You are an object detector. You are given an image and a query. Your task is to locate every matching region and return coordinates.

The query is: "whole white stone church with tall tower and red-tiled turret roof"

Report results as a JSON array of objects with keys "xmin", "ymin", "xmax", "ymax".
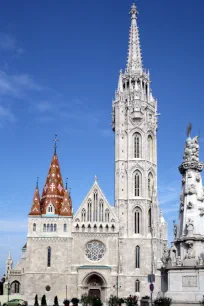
[{"xmin": 5, "ymin": 4, "xmax": 167, "ymax": 303}]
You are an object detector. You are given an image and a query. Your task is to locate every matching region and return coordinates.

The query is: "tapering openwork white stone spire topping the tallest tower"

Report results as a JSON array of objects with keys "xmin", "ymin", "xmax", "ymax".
[{"xmin": 126, "ymin": 3, "xmax": 142, "ymax": 74}]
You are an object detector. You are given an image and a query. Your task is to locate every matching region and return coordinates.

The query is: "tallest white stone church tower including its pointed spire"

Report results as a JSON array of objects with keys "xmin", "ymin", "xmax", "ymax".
[{"xmin": 112, "ymin": 4, "xmax": 167, "ymax": 294}]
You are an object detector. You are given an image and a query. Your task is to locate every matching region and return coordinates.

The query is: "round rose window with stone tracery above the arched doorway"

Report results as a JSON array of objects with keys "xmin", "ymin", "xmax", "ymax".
[{"xmin": 85, "ymin": 240, "xmax": 105, "ymax": 261}]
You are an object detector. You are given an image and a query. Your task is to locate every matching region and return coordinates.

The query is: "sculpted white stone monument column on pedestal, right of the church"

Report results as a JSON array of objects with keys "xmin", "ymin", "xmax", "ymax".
[{"xmin": 163, "ymin": 125, "xmax": 204, "ymax": 305}]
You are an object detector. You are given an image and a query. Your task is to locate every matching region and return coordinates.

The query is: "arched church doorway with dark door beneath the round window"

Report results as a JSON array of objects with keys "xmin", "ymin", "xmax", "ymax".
[{"xmin": 84, "ymin": 272, "xmax": 107, "ymax": 302}]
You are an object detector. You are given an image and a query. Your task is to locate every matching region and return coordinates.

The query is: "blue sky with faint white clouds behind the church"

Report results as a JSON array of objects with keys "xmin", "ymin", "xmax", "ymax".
[{"xmin": 0, "ymin": 0, "xmax": 204, "ymax": 275}]
